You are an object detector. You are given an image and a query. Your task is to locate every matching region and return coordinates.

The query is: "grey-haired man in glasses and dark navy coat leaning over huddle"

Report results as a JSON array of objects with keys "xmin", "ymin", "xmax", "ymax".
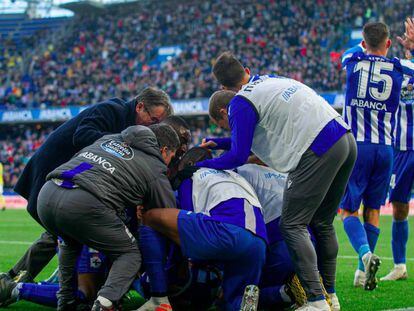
[{"xmin": 0, "ymin": 87, "xmax": 172, "ymax": 286}]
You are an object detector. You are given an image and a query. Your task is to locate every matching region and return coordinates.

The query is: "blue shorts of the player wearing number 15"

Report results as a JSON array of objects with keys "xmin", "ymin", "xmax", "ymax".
[{"xmin": 341, "ymin": 144, "xmax": 393, "ymax": 212}]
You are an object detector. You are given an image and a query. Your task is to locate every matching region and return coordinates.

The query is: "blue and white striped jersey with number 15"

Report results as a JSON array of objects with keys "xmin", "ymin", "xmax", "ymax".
[{"xmin": 342, "ymin": 46, "xmax": 414, "ymax": 145}]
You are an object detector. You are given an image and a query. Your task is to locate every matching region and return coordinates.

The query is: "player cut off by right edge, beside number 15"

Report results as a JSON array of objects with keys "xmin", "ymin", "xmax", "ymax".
[{"xmin": 381, "ymin": 73, "xmax": 414, "ymax": 281}]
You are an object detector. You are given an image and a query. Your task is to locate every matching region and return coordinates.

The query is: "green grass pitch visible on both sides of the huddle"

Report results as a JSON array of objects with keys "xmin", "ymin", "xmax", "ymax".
[{"xmin": 0, "ymin": 210, "xmax": 414, "ymax": 311}]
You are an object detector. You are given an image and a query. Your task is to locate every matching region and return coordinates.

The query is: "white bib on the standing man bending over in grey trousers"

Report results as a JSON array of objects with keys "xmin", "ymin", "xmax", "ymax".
[{"xmin": 236, "ymin": 76, "xmax": 349, "ymax": 173}]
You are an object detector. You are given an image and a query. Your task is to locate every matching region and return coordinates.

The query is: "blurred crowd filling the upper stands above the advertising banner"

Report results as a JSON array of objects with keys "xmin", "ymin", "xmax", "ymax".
[{"xmin": 0, "ymin": 0, "xmax": 414, "ymax": 109}]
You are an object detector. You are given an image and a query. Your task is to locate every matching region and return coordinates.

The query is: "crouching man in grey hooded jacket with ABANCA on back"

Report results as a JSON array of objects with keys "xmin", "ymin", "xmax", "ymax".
[{"xmin": 38, "ymin": 124, "xmax": 180, "ymax": 311}]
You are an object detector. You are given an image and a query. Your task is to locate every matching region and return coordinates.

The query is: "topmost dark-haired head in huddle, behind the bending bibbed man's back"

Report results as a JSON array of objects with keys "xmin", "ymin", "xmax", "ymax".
[{"xmin": 213, "ymin": 52, "xmax": 245, "ymax": 88}]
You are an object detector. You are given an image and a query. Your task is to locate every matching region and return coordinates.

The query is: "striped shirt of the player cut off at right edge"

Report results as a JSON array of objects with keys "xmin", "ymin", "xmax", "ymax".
[{"xmin": 394, "ymin": 77, "xmax": 414, "ymax": 151}]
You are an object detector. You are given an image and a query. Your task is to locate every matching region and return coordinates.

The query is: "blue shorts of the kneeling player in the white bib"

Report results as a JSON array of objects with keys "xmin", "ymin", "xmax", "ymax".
[{"xmin": 178, "ymin": 211, "xmax": 266, "ymax": 311}]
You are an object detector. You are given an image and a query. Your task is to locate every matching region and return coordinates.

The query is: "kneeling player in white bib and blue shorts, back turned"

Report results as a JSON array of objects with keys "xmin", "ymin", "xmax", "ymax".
[{"xmin": 139, "ymin": 148, "xmax": 267, "ymax": 311}]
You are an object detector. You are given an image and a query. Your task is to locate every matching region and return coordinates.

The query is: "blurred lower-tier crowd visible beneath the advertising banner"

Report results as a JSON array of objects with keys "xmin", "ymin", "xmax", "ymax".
[{"xmin": 0, "ymin": 116, "xmax": 227, "ymax": 189}]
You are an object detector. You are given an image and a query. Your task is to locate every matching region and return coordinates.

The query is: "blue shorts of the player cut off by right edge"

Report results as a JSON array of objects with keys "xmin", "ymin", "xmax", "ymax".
[{"xmin": 390, "ymin": 150, "xmax": 414, "ymax": 203}]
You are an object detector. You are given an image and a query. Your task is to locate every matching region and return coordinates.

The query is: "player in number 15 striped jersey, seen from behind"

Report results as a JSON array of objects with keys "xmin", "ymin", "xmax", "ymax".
[{"xmin": 341, "ymin": 22, "xmax": 414, "ymax": 290}]
